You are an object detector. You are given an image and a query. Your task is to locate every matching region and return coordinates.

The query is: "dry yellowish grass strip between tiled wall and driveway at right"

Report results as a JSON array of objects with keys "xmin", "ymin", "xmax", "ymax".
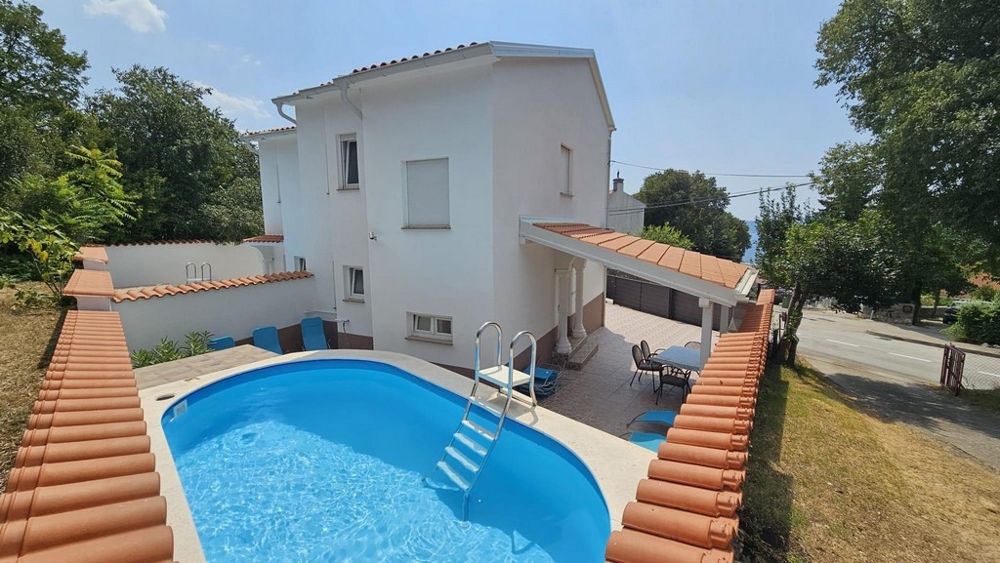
[{"xmin": 741, "ymin": 368, "xmax": 1000, "ymax": 563}]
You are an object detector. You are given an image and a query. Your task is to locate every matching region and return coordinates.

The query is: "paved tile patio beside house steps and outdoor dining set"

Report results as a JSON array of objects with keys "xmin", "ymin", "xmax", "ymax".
[{"xmin": 542, "ymin": 303, "xmax": 719, "ymax": 437}]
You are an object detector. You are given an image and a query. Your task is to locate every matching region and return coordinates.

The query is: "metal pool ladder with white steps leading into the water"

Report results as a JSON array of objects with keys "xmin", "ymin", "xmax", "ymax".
[{"xmin": 437, "ymin": 321, "xmax": 538, "ymax": 520}]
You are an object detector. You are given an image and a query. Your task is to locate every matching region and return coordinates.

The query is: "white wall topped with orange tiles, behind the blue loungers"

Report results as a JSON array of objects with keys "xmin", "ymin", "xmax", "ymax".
[{"xmin": 111, "ymin": 278, "xmax": 315, "ymax": 350}]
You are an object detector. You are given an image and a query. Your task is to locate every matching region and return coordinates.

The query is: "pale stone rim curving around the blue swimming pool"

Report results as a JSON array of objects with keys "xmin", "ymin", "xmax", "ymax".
[{"xmin": 137, "ymin": 346, "xmax": 655, "ymax": 563}]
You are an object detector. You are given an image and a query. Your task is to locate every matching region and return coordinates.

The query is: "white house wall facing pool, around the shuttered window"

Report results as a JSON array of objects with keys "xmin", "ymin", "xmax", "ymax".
[{"xmin": 362, "ymin": 61, "xmax": 496, "ymax": 367}]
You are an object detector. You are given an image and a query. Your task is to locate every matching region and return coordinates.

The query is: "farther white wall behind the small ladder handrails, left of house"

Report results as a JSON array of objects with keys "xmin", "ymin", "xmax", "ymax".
[{"xmin": 105, "ymin": 242, "xmax": 267, "ymax": 288}]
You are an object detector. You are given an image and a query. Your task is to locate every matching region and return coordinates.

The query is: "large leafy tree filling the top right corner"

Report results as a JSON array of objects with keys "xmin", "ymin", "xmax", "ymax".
[{"xmin": 816, "ymin": 0, "xmax": 1000, "ymax": 272}]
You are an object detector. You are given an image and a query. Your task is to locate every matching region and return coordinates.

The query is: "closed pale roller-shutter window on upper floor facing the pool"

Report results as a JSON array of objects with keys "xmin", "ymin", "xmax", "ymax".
[{"xmin": 403, "ymin": 158, "xmax": 451, "ymax": 229}]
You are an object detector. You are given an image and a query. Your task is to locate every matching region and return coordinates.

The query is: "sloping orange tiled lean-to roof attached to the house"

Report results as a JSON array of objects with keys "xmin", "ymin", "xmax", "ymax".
[{"xmin": 535, "ymin": 223, "xmax": 749, "ymax": 289}]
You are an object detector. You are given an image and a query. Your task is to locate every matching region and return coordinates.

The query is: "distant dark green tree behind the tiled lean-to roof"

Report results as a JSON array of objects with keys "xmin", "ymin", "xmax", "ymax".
[{"xmin": 635, "ymin": 169, "xmax": 750, "ymax": 261}]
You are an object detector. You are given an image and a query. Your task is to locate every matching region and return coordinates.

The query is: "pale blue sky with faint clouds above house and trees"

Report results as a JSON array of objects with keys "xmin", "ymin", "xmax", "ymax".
[{"xmin": 34, "ymin": 0, "xmax": 861, "ymax": 219}]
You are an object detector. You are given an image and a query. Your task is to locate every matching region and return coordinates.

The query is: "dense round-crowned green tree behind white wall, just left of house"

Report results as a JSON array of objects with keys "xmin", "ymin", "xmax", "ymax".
[{"xmin": 87, "ymin": 65, "xmax": 261, "ymax": 241}]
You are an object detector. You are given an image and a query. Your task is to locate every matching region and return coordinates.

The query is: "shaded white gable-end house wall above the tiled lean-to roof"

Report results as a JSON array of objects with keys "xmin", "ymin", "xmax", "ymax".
[{"xmin": 492, "ymin": 59, "xmax": 609, "ymax": 348}]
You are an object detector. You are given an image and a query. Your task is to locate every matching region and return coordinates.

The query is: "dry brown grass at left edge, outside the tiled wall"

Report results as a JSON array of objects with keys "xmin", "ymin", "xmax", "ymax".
[{"xmin": 0, "ymin": 284, "xmax": 64, "ymax": 491}]
